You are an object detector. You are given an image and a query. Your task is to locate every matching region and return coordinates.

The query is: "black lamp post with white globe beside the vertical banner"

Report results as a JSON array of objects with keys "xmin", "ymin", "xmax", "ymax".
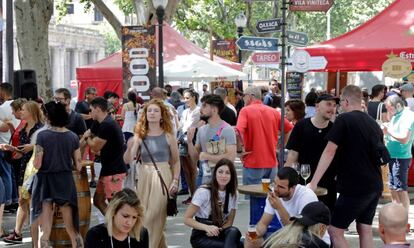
[{"xmin": 152, "ymin": 0, "xmax": 168, "ymax": 88}]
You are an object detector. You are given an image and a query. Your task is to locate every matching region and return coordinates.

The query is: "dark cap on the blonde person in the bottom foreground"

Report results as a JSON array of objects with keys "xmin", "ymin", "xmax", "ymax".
[{"xmin": 290, "ymin": 201, "xmax": 331, "ymax": 226}]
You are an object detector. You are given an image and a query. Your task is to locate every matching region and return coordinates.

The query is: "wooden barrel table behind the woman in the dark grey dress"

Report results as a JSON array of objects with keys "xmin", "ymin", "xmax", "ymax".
[{"xmin": 50, "ymin": 160, "xmax": 93, "ymax": 247}]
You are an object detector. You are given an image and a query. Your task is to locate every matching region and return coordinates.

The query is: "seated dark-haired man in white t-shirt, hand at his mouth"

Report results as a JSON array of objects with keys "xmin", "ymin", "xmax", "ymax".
[{"xmin": 245, "ymin": 167, "xmax": 330, "ymax": 247}]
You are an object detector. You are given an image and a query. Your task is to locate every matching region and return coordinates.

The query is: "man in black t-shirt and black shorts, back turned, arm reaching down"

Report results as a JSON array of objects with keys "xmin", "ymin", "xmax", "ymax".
[{"xmin": 309, "ymin": 85, "xmax": 383, "ymax": 247}]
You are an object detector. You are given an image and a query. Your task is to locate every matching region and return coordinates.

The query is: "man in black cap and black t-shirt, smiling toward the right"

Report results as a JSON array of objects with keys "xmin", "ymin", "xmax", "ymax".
[{"xmin": 286, "ymin": 94, "xmax": 339, "ymax": 212}]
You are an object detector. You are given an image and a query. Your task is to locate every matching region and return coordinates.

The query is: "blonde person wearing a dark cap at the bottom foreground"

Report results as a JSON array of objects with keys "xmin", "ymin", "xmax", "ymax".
[{"xmin": 263, "ymin": 202, "xmax": 330, "ymax": 248}]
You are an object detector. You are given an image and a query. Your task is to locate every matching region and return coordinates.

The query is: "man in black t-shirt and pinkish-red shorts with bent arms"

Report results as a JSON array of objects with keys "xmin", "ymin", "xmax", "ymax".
[{"xmin": 81, "ymin": 97, "xmax": 126, "ymax": 215}]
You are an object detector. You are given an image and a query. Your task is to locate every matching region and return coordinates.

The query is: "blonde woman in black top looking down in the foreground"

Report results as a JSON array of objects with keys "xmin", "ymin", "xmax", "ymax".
[{"xmin": 85, "ymin": 188, "xmax": 149, "ymax": 248}]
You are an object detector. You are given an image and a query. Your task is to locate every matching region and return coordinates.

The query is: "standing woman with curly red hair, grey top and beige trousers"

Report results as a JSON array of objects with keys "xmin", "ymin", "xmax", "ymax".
[{"xmin": 124, "ymin": 99, "xmax": 180, "ymax": 248}]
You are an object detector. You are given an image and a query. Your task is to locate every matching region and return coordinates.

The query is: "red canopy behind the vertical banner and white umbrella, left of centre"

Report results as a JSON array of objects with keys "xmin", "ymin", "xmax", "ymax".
[{"xmin": 76, "ymin": 25, "xmax": 242, "ymax": 98}]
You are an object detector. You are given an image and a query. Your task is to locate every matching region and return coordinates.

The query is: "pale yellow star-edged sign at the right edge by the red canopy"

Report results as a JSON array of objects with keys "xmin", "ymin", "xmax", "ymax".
[{"xmin": 382, "ymin": 53, "xmax": 413, "ymax": 78}]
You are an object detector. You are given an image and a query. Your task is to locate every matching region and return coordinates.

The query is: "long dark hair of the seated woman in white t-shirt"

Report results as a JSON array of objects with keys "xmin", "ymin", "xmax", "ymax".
[{"xmin": 208, "ymin": 158, "xmax": 238, "ymax": 227}]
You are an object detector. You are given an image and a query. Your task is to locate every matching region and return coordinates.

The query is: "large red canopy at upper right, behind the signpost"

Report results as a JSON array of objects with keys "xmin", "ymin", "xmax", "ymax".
[{"xmin": 304, "ymin": 0, "xmax": 414, "ymax": 71}]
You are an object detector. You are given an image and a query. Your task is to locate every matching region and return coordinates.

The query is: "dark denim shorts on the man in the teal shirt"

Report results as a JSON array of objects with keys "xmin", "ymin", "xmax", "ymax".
[{"xmin": 389, "ymin": 158, "xmax": 411, "ymax": 191}]
